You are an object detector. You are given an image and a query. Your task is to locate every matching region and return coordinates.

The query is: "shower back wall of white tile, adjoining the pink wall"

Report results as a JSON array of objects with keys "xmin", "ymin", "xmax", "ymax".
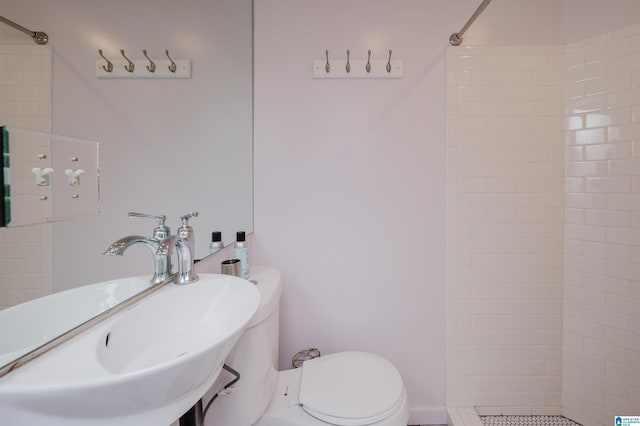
[{"xmin": 447, "ymin": 46, "xmax": 564, "ymax": 414}]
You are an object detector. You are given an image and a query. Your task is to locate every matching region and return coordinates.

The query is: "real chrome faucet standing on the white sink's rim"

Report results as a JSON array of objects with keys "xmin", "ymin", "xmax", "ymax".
[{"xmin": 156, "ymin": 212, "xmax": 198, "ymax": 284}]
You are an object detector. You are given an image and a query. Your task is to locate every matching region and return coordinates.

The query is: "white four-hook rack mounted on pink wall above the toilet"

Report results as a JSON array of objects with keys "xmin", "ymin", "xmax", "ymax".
[{"xmin": 313, "ymin": 50, "xmax": 404, "ymax": 78}]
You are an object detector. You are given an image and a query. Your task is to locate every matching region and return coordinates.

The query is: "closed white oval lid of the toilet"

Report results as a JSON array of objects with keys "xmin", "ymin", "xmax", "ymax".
[{"xmin": 299, "ymin": 352, "xmax": 404, "ymax": 426}]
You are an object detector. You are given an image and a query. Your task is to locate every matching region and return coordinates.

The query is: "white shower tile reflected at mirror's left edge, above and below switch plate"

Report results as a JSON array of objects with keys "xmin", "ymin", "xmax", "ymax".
[{"xmin": 0, "ymin": 45, "xmax": 53, "ymax": 309}]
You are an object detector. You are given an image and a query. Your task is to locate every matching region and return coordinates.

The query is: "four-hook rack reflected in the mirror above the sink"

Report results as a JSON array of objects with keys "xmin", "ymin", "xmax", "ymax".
[{"xmin": 96, "ymin": 49, "xmax": 191, "ymax": 79}]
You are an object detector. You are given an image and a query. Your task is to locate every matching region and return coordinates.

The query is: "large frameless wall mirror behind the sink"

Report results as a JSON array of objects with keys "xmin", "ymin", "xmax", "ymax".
[{"xmin": 0, "ymin": 0, "xmax": 253, "ymax": 370}]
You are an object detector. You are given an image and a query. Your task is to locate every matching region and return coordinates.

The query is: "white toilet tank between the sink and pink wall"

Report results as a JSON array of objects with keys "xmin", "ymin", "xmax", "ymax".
[{"xmin": 203, "ymin": 266, "xmax": 282, "ymax": 426}]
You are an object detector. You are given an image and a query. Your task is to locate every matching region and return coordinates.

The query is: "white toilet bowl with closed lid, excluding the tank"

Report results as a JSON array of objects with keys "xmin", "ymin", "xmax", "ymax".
[{"xmin": 256, "ymin": 352, "xmax": 409, "ymax": 426}]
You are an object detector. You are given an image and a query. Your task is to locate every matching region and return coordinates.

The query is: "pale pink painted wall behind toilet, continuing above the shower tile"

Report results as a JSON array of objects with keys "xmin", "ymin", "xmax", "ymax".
[{"xmin": 254, "ymin": 0, "xmax": 563, "ymax": 424}]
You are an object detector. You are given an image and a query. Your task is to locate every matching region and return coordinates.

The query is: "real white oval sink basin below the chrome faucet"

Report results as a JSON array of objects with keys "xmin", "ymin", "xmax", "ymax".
[{"xmin": 0, "ymin": 274, "xmax": 260, "ymax": 426}]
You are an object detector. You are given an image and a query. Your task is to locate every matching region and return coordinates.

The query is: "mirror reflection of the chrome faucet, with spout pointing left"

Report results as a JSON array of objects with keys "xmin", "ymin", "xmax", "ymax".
[{"xmin": 104, "ymin": 212, "xmax": 173, "ymax": 284}]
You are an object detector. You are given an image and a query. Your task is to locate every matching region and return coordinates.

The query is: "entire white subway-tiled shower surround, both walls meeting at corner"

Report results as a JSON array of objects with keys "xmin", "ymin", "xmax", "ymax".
[{"xmin": 447, "ymin": 26, "xmax": 640, "ymax": 426}]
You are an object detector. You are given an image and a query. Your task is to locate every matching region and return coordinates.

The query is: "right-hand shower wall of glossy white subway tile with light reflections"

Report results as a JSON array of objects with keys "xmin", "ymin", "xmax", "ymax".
[{"xmin": 563, "ymin": 25, "xmax": 640, "ymax": 426}]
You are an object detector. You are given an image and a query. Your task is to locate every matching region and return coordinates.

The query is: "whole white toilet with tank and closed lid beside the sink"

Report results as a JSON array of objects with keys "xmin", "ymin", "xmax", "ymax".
[{"xmin": 205, "ymin": 266, "xmax": 409, "ymax": 426}]
